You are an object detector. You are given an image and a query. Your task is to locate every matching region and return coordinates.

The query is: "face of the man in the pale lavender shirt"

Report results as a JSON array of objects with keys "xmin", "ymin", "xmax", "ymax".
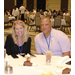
[{"xmin": 41, "ymin": 18, "xmax": 51, "ymax": 34}]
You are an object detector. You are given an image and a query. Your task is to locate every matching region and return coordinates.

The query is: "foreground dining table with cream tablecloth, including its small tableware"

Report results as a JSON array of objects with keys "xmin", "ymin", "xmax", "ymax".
[{"xmin": 4, "ymin": 49, "xmax": 71, "ymax": 75}]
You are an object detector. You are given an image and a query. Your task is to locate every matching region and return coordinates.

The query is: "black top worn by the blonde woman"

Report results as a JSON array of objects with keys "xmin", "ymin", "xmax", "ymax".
[{"xmin": 5, "ymin": 35, "xmax": 31, "ymax": 55}]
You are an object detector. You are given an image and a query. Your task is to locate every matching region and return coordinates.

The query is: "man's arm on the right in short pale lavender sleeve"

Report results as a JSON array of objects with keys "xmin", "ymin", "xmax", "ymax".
[{"xmin": 58, "ymin": 33, "xmax": 71, "ymax": 57}]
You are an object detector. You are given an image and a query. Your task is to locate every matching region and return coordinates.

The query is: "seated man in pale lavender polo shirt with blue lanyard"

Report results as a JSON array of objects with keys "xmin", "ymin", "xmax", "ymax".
[{"xmin": 34, "ymin": 17, "xmax": 71, "ymax": 56}]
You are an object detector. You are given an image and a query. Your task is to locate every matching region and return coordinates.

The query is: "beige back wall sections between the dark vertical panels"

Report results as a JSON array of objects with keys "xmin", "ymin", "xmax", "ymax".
[{"xmin": 14, "ymin": 0, "xmax": 71, "ymax": 12}]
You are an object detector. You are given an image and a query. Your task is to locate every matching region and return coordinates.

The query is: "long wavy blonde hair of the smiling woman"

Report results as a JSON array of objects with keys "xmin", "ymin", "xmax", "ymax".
[{"xmin": 12, "ymin": 20, "xmax": 29, "ymax": 44}]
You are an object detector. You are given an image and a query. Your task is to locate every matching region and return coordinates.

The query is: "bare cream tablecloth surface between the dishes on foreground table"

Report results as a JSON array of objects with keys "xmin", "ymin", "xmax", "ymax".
[{"xmin": 4, "ymin": 55, "xmax": 71, "ymax": 75}]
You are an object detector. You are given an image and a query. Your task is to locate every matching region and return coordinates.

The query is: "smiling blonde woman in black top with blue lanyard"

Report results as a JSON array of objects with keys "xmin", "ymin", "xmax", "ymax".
[{"xmin": 5, "ymin": 20, "xmax": 31, "ymax": 55}]
